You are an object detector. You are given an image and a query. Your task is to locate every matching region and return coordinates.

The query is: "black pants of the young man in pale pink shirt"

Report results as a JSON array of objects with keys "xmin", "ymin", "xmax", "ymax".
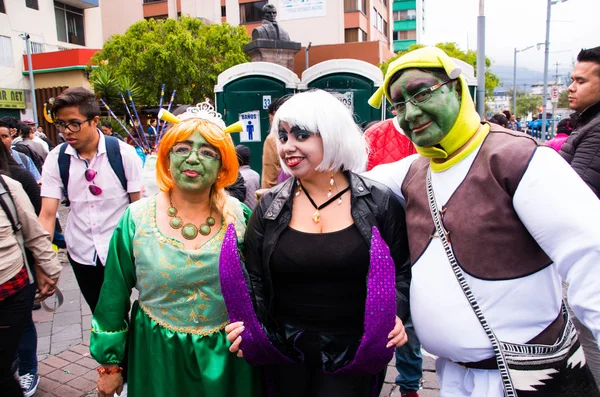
[{"xmin": 67, "ymin": 255, "xmax": 129, "ymax": 382}]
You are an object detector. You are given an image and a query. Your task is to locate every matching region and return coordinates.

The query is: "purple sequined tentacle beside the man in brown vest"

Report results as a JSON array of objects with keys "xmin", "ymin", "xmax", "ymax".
[{"xmin": 332, "ymin": 226, "xmax": 396, "ymax": 375}]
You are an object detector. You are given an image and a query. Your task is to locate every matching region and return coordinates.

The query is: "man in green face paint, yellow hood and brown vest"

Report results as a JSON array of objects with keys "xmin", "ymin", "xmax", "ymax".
[{"xmin": 367, "ymin": 47, "xmax": 600, "ymax": 397}]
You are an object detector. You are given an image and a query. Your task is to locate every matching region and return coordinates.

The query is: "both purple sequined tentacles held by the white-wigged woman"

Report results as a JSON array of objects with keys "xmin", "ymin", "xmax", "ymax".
[{"xmin": 219, "ymin": 225, "xmax": 396, "ymax": 375}]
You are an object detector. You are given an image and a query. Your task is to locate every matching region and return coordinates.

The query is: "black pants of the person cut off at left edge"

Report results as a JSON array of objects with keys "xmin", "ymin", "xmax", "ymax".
[{"xmin": 0, "ymin": 284, "xmax": 35, "ymax": 397}]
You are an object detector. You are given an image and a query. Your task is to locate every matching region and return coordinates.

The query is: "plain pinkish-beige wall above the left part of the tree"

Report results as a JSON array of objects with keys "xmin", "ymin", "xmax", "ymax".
[{"xmin": 100, "ymin": 0, "xmax": 144, "ymax": 41}]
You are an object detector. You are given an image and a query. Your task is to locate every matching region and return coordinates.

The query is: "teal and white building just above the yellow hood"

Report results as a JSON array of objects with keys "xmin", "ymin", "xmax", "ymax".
[{"xmin": 392, "ymin": 0, "xmax": 425, "ymax": 52}]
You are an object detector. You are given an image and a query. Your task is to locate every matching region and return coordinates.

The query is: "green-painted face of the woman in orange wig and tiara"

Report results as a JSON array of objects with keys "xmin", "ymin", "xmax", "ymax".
[{"xmin": 169, "ymin": 132, "xmax": 221, "ymax": 191}]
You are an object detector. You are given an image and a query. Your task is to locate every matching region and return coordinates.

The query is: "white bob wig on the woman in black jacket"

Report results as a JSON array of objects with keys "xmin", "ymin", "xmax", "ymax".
[{"xmin": 270, "ymin": 90, "xmax": 368, "ymax": 174}]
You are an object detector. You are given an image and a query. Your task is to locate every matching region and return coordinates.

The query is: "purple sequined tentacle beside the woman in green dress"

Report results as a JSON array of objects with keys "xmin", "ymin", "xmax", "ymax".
[{"xmin": 219, "ymin": 224, "xmax": 296, "ymax": 365}]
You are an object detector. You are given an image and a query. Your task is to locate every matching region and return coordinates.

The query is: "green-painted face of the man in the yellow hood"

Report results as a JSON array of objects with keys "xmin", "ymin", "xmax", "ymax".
[{"xmin": 390, "ymin": 69, "xmax": 460, "ymax": 147}]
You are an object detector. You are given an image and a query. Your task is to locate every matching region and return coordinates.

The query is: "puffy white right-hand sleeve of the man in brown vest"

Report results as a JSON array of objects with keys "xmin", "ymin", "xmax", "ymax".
[{"xmin": 513, "ymin": 147, "xmax": 600, "ymax": 341}]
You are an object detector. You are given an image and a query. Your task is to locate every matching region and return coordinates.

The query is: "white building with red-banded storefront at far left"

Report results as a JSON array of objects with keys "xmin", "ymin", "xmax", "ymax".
[{"xmin": 0, "ymin": 0, "xmax": 102, "ymax": 122}]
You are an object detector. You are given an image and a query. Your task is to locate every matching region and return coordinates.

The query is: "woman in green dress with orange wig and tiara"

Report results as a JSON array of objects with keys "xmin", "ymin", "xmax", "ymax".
[{"xmin": 90, "ymin": 104, "xmax": 262, "ymax": 397}]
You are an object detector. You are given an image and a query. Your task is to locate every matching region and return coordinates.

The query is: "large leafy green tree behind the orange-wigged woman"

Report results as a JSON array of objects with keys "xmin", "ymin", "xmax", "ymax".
[{"xmin": 91, "ymin": 16, "xmax": 250, "ymax": 105}]
